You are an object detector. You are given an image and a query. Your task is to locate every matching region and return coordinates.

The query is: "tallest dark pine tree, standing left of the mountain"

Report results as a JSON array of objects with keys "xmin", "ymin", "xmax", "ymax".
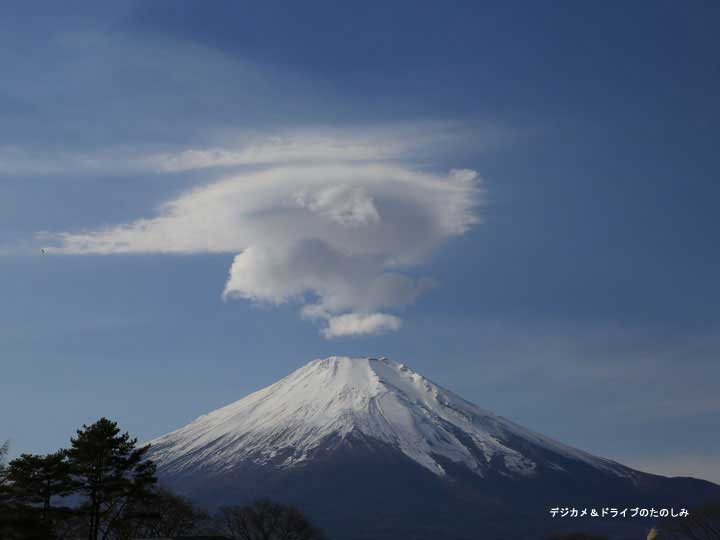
[{"xmin": 68, "ymin": 418, "xmax": 156, "ymax": 540}]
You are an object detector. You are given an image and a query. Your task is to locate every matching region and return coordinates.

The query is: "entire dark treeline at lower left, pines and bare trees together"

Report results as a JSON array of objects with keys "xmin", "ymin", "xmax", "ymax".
[{"xmin": 0, "ymin": 418, "xmax": 324, "ymax": 540}]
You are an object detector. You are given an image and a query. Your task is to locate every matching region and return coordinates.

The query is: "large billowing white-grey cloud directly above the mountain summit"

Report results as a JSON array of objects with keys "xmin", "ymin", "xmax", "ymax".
[{"xmin": 47, "ymin": 163, "xmax": 479, "ymax": 338}]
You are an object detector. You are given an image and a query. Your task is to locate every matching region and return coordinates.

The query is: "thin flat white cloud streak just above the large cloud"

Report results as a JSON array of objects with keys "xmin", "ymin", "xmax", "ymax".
[{"xmin": 0, "ymin": 122, "xmax": 490, "ymax": 176}]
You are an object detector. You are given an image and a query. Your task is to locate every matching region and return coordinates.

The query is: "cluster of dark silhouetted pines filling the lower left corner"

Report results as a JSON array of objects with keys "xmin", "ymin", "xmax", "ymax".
[{"xmin": 0, "ymin": 418, "xmax": 158, "ymax": 540}]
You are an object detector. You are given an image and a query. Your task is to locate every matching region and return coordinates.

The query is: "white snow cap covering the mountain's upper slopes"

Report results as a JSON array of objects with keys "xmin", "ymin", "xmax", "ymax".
[{"xmin": 151, "ymin": 357, "xmax": 633, "ymax": 479}]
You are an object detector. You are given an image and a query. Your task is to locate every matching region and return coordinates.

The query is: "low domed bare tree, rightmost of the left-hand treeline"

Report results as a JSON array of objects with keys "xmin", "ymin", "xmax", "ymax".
[{"xmin": 218, "ymin": 501, "xmax": 325, "ymax": 540}]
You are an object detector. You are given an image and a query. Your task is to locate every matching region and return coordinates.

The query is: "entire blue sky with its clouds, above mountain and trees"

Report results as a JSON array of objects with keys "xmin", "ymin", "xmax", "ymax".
[{"xmin": 0, "ymin": 1, "xmax": 720, "ymax": 482}]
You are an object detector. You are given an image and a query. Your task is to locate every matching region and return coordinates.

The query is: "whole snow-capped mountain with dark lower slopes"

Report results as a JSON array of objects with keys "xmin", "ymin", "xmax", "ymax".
[{"xmin": 146, "ymin": 357, "xmax": 720, "ymax": 540}]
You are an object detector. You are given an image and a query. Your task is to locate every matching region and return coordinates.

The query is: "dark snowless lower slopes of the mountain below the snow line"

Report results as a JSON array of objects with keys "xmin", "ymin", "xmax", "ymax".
[{"xmin": 160, "ymin": 433, "xmax": 720, "ymax": 540}]
